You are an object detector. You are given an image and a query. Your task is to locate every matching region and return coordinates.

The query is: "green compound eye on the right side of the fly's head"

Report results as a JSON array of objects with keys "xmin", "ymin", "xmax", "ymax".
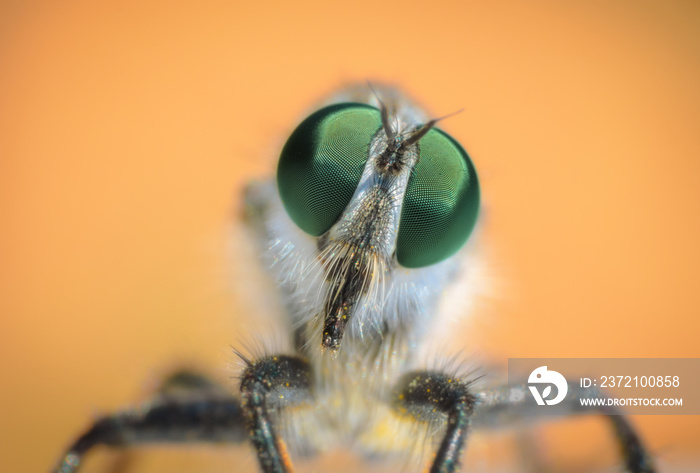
[{"xmin": 396, "ymin": 128, "xmax": 479, "ymax": 268}]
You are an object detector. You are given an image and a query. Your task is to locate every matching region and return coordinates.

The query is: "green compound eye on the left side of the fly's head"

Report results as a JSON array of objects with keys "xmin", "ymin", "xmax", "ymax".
[{"xmin": 277, "ymin": 103, "xmax": 382, "ymax": 236}]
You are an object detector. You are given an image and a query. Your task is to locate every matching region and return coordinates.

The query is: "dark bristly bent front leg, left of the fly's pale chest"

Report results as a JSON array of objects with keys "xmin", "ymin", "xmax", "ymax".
[{"xmin": 241, "ymin": 356, "xmax": 312, "ymax": 473}]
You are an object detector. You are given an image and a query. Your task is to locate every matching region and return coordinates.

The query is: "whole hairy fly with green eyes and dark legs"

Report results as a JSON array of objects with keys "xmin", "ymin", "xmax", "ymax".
[{"xmin": 54, "ymin": 85, "xmax": 655, "ymax": 473}]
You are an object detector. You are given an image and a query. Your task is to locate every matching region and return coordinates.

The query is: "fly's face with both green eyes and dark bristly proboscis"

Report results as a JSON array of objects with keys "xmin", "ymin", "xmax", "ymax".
[{"xmin": 277, "ymin": 98, "xmax": 479, "ymax": 350}]
